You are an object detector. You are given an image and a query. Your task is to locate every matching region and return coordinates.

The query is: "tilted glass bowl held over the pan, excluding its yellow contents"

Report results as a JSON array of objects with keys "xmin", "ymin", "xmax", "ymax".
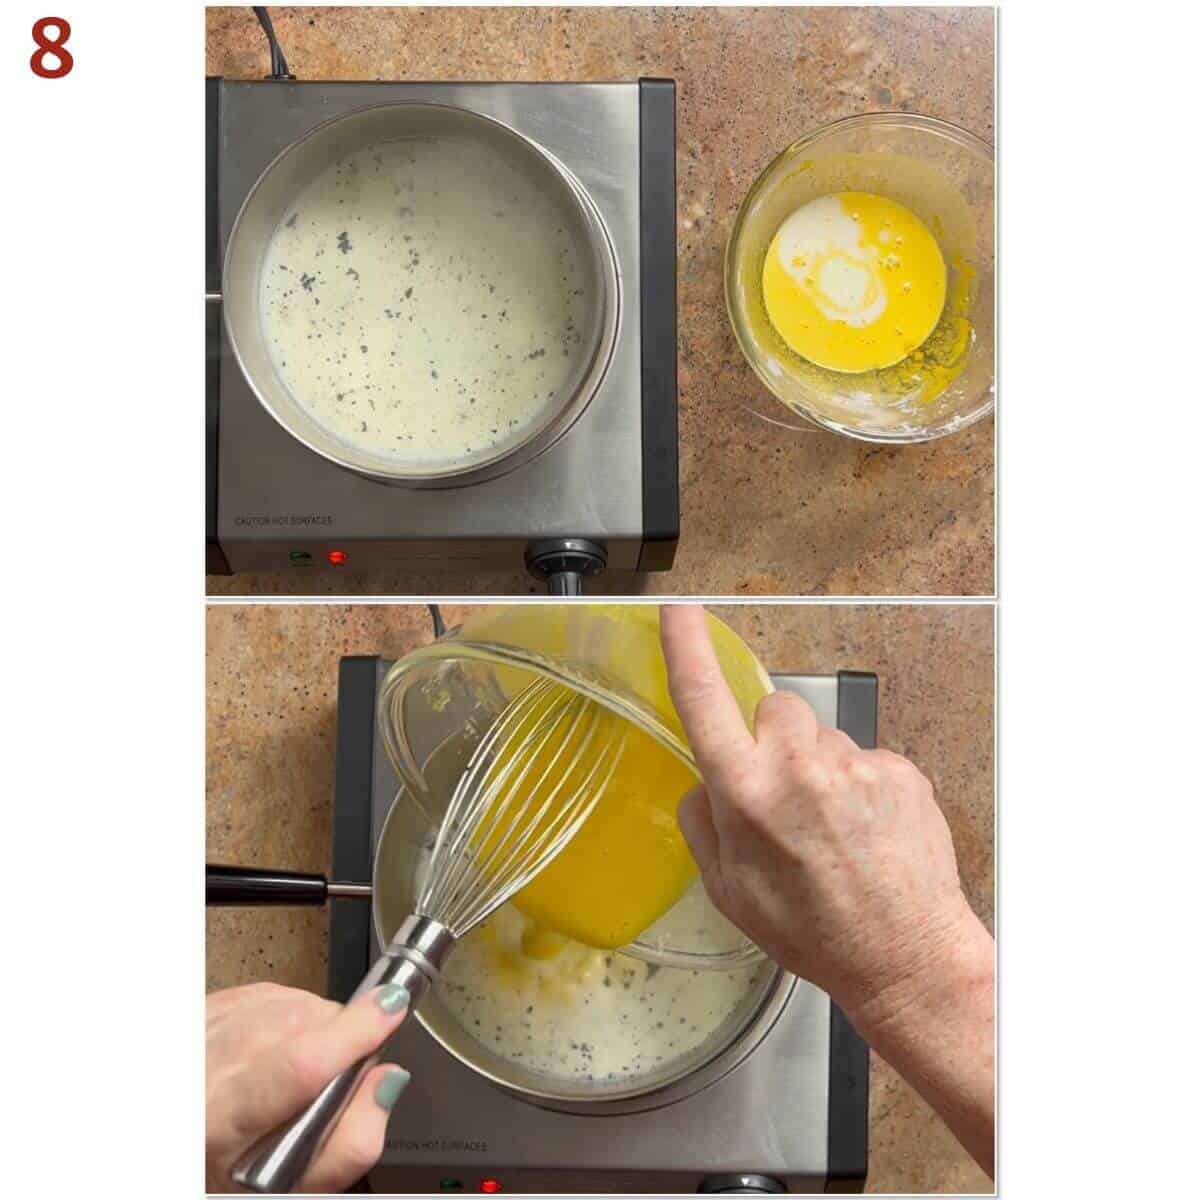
[{"xmin": 379, "ymin": 605, "xmax": 773, "ymax": 970}]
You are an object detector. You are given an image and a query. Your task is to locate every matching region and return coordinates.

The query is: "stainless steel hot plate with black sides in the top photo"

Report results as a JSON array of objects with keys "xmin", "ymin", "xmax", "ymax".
[{"xmin": 206, "ymin": 79, "xmax": 679, "ymax": 593}]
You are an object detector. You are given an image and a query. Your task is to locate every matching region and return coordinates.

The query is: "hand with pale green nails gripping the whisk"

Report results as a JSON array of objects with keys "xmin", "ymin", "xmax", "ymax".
[{"xmin": 205, "ymin": 983, "xmax": 408, "ymax": 1192}]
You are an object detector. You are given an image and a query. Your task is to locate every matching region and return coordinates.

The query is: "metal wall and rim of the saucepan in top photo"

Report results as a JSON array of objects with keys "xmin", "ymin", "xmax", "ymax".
[{"xmin": 222, "ymin": 101, "xmax": 620, "ymax": 487}]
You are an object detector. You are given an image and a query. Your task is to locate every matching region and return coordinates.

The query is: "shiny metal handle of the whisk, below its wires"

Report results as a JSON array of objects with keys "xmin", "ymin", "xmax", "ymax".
[{"xmin": 233, "ymin": 917, "xmax": 454, "ymax": 1193}]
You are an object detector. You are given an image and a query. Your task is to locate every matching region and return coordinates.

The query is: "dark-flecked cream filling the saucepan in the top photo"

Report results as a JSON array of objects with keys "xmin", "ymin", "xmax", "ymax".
[{"xmin": 259, "ymin": 138, "xmax": 593, "ymax": 470}]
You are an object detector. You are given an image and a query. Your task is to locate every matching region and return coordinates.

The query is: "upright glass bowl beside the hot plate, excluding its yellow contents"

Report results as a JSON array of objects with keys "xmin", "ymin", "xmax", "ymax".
[{"xmin": 725, "ymin": 113, "xmax": 995, "ymax": 443}]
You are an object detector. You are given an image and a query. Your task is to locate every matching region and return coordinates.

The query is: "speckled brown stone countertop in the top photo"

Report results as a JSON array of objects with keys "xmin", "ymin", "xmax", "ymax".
[{"xmin": 206, "ymin": 7, "xmax": 995, "ymax": 596}]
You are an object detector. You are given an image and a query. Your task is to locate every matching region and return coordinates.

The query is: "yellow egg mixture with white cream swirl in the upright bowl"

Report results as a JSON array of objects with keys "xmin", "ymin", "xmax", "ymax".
[{"xmin": 762, "ymin": 192, "xmax": 947, "ymax": 373}]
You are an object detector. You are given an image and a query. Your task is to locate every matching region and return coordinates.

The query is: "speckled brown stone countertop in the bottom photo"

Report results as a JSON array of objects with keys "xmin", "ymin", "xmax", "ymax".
[{"xmin": 206, "ymin": 605, "xmax": 995, "ymax": 1193}]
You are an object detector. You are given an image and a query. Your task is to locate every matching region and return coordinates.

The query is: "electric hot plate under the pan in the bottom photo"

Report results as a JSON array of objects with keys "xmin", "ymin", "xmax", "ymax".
[{"xmin": 329, "ymin": 658, "xmax": 877, "ymax": 1194}]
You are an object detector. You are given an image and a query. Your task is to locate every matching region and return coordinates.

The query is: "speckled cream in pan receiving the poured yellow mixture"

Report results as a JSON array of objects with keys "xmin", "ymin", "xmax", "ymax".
[{"xmin": 434, "ymin": 904, "xmax": 772, "ymax": 1082}]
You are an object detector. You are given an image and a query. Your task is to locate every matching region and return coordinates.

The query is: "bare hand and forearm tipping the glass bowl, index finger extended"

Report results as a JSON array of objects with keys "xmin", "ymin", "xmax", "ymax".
[{"xmin": 661, "ymin": 605, "xmax": 995, "ymax": 1172}]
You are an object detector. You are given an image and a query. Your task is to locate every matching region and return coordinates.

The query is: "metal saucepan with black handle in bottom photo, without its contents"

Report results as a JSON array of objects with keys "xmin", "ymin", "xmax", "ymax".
[{"xmin": 206, "ymin": 764, "xmax": 794, "ymax": 1116}]
